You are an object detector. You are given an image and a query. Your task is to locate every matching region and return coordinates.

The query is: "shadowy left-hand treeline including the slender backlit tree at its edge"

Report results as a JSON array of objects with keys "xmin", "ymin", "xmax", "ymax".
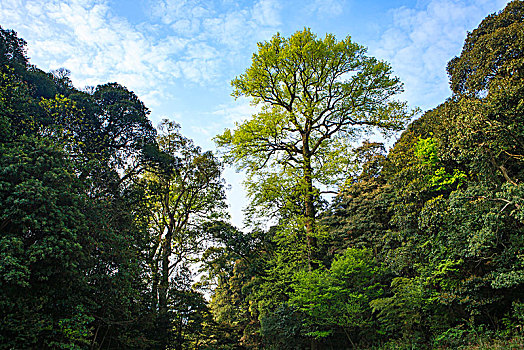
[{"xmin": 0, "ymin": 23, "xmax": 225, "ymax": 349}]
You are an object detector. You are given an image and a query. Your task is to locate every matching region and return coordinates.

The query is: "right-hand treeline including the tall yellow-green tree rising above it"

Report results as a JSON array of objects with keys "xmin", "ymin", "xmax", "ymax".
[{"xmin": 206, "ymin": 1, "xmax": 524, "ymax": 349}]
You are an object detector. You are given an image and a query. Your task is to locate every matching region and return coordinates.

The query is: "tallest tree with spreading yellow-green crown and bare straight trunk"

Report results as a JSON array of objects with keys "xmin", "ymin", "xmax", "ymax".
[{"xmin": 216, "ymin": 28, "xmax": 409, "ymax": 262}]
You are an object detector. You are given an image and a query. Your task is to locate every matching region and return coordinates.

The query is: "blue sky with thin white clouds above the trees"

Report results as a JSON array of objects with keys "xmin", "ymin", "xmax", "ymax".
[{"xmin": 0, "ymin": 0, "xmax": 508, "ymax": 227}]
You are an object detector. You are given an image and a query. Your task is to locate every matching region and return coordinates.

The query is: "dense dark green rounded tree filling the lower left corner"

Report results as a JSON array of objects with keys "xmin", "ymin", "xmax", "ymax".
[{"xmin": 0, "ymin": 138, "xmax": 93, "ymax": 349}]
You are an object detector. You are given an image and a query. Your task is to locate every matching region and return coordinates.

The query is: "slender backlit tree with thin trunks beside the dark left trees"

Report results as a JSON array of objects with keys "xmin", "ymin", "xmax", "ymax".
[{"xmin": 143, "ymin": 120, "xmax": 225, "ymax": 349}]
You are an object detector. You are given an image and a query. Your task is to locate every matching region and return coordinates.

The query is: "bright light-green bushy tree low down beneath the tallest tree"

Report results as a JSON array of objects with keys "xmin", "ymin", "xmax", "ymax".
[{"xmin": 290, "ymin": 248, "xmax": 385, "ymax": 344}]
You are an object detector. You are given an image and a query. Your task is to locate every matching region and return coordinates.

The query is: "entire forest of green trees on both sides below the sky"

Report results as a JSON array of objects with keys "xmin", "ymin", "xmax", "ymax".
[{"xmin": 0, "ymin": 0, "xmax": 524, "ymax": 350}]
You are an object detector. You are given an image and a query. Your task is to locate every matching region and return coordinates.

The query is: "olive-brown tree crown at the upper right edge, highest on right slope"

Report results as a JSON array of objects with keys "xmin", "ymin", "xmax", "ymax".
[{"xmin": 448, "ymin": 1, "xmax": 524, "ymax": 184}]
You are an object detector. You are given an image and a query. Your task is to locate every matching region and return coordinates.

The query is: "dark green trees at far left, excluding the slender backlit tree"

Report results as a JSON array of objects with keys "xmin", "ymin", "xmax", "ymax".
[{"xmin": 0, "ymin": 25, "xmax": 160, "ymax": 349}]
